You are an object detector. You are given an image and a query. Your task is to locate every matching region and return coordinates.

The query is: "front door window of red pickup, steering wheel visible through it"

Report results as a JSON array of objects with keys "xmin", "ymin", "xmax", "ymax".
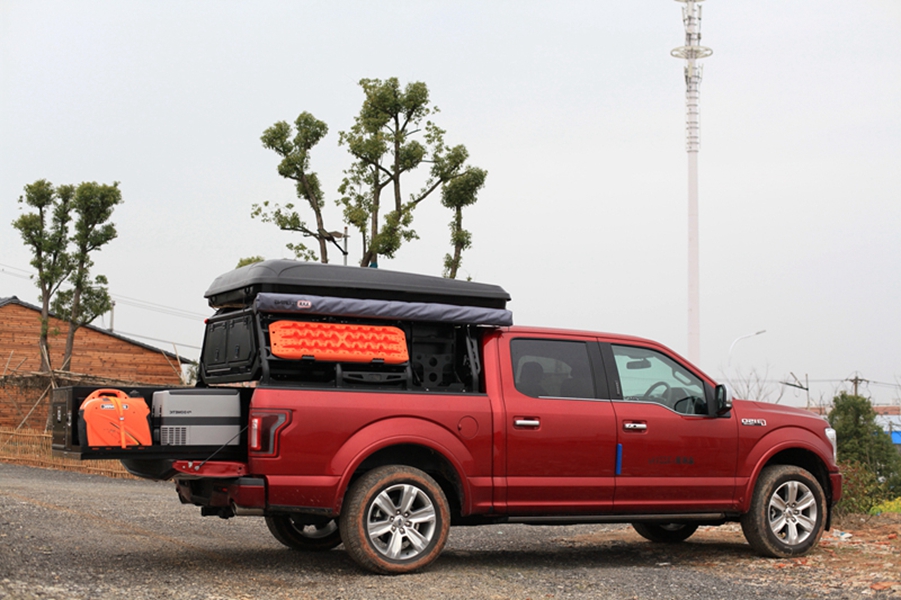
[{"xmin": 613, "ymin": 345, "xmax": 707, "ymax": 415}]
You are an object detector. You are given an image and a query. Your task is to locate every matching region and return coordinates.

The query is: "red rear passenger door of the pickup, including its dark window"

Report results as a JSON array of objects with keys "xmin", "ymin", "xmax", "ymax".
[{"xmin": 500, "ymin": 335, "xmax": 616, "ymax": 514}]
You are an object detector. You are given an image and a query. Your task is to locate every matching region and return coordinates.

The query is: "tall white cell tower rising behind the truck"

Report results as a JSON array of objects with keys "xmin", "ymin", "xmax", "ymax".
[{"xmin": 670, "ymin": 0, "xmax": 713, "ymax": 364}]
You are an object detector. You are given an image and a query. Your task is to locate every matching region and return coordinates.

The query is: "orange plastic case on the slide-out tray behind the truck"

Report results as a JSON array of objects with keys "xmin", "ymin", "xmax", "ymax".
[{"xmin": 79, "ymin": 389, "xmax": 153, "ymax": 448}]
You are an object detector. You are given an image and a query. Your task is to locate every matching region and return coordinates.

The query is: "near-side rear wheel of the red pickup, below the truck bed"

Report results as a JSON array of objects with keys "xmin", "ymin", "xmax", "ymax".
[{"xmin": 340, "ymin": 465, "xmax": 450, "ymax": 574}]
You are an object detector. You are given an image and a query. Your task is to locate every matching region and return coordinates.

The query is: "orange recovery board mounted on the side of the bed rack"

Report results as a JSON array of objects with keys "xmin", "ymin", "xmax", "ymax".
[{"xmin": 269, "ymin": 321, "xmax": 409, "ymax": 365}]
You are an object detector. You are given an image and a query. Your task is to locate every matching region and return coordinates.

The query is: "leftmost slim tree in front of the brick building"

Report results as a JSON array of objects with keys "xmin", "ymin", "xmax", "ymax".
[{"xmin": 12, "ymin": 179, "xmax": 75, "ymax": 371}]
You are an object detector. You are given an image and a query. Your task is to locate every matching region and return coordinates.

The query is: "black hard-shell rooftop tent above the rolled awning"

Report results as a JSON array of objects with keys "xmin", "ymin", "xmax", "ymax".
[{"xmin": 204, "ymin": 260, "xmax": 510, "ymax": 309}]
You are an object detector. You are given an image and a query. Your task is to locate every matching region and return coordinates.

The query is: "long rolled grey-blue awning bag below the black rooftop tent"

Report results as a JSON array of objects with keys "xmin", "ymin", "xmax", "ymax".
[{"xmin": 254, "ymin": 292, "xmax": 513, "ymax": 326}]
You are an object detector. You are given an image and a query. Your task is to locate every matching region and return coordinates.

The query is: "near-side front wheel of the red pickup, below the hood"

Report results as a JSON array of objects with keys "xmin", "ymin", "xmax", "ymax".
[{"xmin": 741, "ymin": 465, "xmax": 827, "ymax": 558}]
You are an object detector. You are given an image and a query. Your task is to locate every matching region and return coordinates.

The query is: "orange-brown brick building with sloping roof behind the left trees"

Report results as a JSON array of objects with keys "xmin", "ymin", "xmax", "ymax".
[{"xmin": 0, "ymin": 296, "xmax": 190, "ymax": 427}]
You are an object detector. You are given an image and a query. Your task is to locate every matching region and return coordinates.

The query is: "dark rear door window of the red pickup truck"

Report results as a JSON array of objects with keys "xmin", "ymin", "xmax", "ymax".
[{"xmin": 510, "ymin": 339, "xmax": 597, "ymax": 398}]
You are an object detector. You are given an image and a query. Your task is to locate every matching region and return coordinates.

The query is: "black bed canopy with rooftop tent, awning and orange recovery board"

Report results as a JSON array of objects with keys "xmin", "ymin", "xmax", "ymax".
[{"xmin": 200, "ymin": 260, "xmax": 513, "ymax": 392}]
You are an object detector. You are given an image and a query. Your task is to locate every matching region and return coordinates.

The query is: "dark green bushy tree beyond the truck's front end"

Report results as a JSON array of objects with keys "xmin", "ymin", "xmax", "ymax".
[{"xmin": 828, "ymin": 392, "xmax": 901, "ymax": 501}]
